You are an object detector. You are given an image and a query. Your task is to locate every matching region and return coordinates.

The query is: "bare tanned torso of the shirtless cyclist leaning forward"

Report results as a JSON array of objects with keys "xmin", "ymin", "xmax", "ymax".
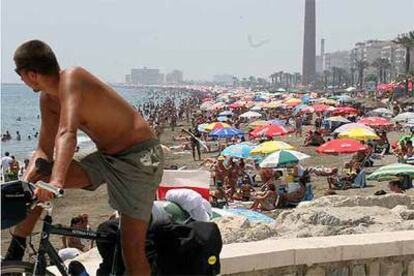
[{"xmin": 41, "ymin": 68, "xmax": 155, "ymax": 154}]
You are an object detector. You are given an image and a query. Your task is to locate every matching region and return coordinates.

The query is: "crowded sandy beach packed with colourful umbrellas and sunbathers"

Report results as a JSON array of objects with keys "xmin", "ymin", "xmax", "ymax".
[{"xmin": 2, "ymin": 84, "xmax": 414, "ymax": 256}]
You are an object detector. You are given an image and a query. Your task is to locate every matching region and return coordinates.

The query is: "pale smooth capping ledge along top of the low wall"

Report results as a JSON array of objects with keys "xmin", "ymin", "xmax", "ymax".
[{"xmin": 220, "ymin": 231, "xmax": 414, "ymax": 274}]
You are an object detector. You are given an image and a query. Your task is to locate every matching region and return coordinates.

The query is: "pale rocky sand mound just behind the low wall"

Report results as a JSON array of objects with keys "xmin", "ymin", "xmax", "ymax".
[{"xmin": 216, "ymin": 194, "xmax": 414, "ymax": 243}]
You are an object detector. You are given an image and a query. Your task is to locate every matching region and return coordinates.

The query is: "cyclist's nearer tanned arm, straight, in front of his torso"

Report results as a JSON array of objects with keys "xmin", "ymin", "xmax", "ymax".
[{"xmin": 50, "ymin": 69, "xmax": 82, "ymax": 187}]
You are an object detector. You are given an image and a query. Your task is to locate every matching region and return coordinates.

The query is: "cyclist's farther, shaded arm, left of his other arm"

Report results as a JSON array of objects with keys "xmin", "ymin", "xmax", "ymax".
[{"xmin": 23, "ymin": 93, "xmax": 59, "ymax": 182}]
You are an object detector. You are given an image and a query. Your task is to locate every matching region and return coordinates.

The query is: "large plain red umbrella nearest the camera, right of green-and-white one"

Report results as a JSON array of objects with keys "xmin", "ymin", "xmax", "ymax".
[{"xmin": 316, "ymin": 139, "xmax": 368, "ymax": 154}]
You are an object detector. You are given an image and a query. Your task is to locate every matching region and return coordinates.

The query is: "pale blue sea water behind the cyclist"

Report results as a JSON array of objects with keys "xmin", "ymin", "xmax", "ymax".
[{"xmin": 1, "ymin": 84, "xmax": 188, "ymax": 161}]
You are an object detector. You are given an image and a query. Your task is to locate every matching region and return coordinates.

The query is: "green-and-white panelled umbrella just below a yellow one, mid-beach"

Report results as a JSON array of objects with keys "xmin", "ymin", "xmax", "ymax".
[{"xmin": 260, "ymin": 150, "xmax": 310, "ymax": 168}]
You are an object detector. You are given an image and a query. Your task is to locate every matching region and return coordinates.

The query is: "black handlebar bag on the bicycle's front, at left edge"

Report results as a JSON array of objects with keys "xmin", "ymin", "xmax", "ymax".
[{"xmin": 1, "ymin": 180, "xmax": 33, "ymax": 230}]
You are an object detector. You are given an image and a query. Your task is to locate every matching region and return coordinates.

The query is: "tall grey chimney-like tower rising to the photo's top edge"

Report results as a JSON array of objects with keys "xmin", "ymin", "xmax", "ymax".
[{"xmin": 302, "ymin": 0, "xmax": 316, "ymax": 85}]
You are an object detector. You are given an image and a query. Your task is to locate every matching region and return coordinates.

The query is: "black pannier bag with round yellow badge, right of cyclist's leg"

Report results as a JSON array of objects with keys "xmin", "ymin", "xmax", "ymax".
[{"xmin": 150, "ymin": 221, "xmax": 223, "ymax": 275}]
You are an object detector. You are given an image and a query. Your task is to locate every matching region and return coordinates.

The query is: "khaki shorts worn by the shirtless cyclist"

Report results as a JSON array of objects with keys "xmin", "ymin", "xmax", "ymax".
[{"xmin": 75, "ymin": 139, "xmax": 164, "ymax": 222}]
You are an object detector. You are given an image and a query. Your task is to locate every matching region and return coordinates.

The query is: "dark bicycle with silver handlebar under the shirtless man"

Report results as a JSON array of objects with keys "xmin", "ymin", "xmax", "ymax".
[{"xmin": 1, "ymin": 181, "xmax": 121, "ymax": 276}]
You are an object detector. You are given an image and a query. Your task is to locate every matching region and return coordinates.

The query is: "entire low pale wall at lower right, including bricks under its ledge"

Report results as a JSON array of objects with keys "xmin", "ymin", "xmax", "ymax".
[{"xmin": 221, "ymin": 231, "xmax": 414, "ymax": 276}]
